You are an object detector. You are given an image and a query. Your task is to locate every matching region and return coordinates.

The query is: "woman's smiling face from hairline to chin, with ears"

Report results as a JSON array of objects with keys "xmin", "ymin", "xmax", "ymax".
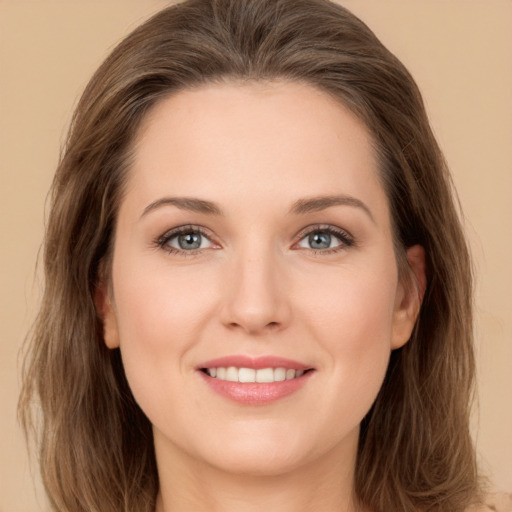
[{"xmin": 97, "ymin": 82, "xmax": 421, "ymax": 474}]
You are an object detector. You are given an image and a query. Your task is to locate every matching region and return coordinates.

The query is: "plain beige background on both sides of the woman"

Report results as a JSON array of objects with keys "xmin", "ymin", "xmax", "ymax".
[{"xmin": 0, "ymin": 0, "xmax": 512, "ymax": 512}]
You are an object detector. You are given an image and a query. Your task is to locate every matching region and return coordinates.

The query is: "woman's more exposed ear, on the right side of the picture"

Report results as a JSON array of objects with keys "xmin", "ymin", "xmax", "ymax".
[{"xmin": 391, "ymin": 245, "xmax": 427, "ymax": 350}]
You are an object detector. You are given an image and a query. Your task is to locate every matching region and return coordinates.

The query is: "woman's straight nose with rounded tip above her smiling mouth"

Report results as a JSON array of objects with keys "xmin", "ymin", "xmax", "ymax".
[{"xmin": 221, "ymin": 250, "xmax": 291, "ymax": 335}]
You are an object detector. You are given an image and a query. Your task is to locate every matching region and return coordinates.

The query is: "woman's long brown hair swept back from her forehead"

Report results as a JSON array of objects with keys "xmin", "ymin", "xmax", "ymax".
[{"xmin": 19, "ymin": 0, "xmax": 478, "ymax": 512}]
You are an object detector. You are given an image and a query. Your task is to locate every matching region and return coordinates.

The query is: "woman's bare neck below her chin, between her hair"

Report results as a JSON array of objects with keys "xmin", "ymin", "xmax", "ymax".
[{"xmin": 155, "ymin": 432, "xmax": 361, "ymax": 512}]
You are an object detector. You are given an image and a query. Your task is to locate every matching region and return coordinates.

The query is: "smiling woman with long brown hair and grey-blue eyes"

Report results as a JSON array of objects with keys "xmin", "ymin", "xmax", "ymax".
[{"xmin": 20, "ymin": 0, "xmax": 480, "ymax": 512}]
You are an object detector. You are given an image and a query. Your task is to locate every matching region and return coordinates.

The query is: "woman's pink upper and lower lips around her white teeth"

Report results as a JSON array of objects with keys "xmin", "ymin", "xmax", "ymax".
[{"xmin": 197, "ymin": 355, "xmax": 315, "ymax": 405}]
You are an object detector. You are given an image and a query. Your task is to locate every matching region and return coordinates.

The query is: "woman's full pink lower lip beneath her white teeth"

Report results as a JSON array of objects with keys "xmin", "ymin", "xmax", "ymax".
[{"xmin": 199, "ymin": 371, "xmax": 314, "ymax": 405}]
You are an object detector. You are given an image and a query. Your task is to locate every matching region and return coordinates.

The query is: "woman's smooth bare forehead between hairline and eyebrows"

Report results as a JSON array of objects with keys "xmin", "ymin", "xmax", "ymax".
[{"xmin": 128, "ymin": 81, "xmax": 387, "ymax": 222}]
